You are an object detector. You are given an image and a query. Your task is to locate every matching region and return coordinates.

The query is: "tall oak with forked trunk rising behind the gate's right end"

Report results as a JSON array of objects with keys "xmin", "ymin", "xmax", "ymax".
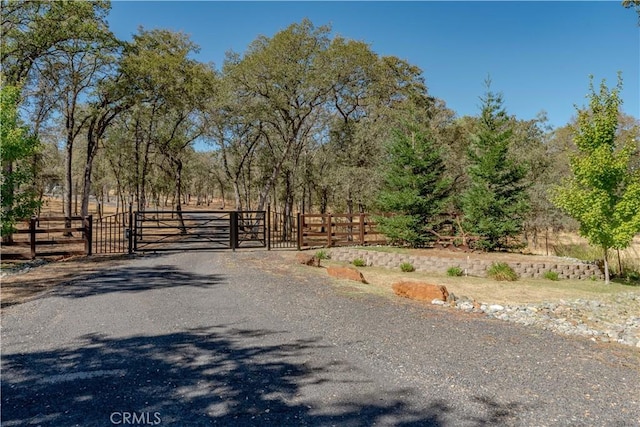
[{"xmin": 224, "ymin": 19, "xmax": 333, "ymax": 214}]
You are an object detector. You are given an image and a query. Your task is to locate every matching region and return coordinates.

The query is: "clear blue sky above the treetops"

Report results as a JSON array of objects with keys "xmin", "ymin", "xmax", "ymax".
[{"xmin": 109, "ymin": 0, "xmax": 640, "ymax": 127}]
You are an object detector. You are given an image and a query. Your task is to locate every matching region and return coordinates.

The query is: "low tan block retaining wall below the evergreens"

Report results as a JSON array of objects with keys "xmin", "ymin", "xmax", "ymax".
[{"xmin": 331, "ymin": 247, "xmax": 604, "ymax": 280}]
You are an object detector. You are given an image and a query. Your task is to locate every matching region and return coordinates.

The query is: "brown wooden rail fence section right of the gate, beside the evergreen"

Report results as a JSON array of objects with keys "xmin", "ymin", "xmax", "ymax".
[{"xmin": 298, "ymin": 213, "xmax": 386, "ymax": 248}]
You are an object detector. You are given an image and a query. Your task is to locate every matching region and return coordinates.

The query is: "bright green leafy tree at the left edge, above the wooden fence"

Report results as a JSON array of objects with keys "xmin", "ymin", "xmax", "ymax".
[{"xmin": 0, "ymin": 84, "xmax": 39, "ymax": 237}]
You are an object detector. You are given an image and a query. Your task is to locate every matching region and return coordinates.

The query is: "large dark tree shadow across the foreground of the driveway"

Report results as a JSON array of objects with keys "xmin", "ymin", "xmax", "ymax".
[{"xmin": 1, "ymin": 326, "xmax": 460, "ymax": 427}]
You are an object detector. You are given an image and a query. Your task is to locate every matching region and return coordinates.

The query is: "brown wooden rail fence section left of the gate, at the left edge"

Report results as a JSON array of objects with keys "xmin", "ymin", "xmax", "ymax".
[{"xmin": 2, "ymin": 215, "xmax": 93, "ymax": 259}]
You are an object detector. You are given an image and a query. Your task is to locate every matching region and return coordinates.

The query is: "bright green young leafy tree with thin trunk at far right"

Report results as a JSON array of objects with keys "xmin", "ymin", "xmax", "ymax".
[{"xmin": 553, "ymin": 76, "xmax": 640, "ymax": 284}]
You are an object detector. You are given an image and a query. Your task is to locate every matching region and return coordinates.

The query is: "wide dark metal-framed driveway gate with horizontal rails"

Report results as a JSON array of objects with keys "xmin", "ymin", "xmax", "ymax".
[{"xmin": 132, "ymin": 211, "xmax": 268, "ymax": 252}]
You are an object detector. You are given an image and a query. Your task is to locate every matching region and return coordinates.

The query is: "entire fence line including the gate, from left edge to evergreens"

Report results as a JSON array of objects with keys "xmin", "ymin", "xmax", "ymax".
[{"xmin": 2, "ymin": 208, "xmax": 386, "ymax": 259}]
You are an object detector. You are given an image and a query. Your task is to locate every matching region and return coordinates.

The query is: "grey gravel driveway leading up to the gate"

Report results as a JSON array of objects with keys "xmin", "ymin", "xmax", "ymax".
[{"xmin": 1, "ymin": 251, "xmax": 640, "ymax": 427}]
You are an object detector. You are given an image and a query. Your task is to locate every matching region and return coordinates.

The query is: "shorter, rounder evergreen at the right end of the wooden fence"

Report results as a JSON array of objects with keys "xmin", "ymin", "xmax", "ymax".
[{"xmin": 377, "ymin": 126, "xmax": 451, "ymax": 247}]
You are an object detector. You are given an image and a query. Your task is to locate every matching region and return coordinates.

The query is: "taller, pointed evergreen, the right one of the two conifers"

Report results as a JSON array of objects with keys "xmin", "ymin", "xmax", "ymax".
[{"xmin": 461, "ymin": 81, "xmax": 529, "ymax": 250}]
